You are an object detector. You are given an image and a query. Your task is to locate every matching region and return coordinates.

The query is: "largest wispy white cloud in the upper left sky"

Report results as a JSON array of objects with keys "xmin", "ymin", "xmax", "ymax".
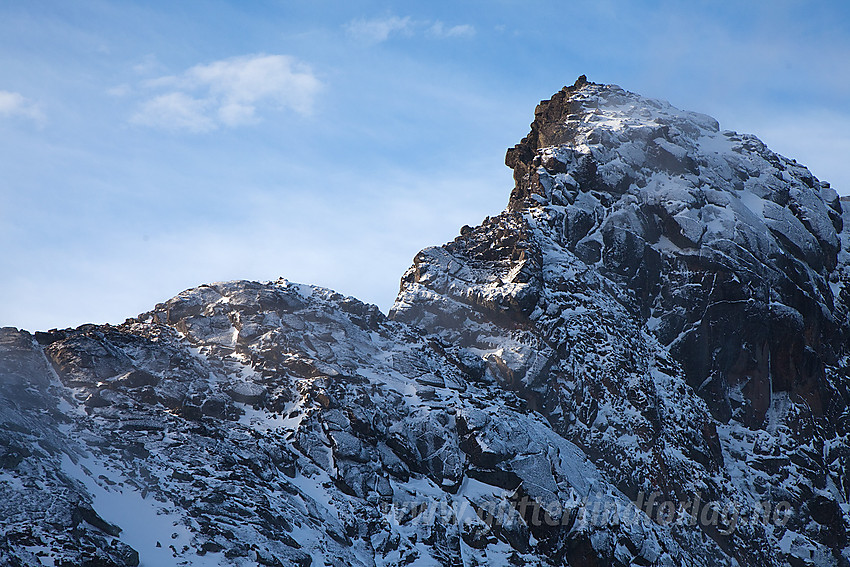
[{"xmin": 131, "ymin": 55, "xmax": 322, "ymax": 132}]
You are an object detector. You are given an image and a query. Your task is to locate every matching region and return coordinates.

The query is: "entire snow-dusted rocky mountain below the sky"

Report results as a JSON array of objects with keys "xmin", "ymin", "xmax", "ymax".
[{"xmin": 0, "ymin": 77, "xmax": 850, "ymax": 567}]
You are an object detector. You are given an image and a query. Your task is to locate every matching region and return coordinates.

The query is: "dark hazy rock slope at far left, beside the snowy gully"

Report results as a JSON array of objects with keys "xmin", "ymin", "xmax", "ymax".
[{"xmin": 0, "ymin": 329, "xmax": 138, "ymax": 566}]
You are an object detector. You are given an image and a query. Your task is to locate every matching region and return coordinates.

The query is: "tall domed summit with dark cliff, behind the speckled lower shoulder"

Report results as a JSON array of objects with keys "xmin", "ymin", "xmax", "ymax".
[{"xmin": 506, "ymin": 76, "xmax": 850, "ymax": 426}]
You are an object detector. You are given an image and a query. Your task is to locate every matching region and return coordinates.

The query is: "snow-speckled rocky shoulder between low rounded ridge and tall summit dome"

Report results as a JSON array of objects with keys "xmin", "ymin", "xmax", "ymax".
[{"xmin": 392, "ymin": 213, "xmax": 722, "ymax": 502}]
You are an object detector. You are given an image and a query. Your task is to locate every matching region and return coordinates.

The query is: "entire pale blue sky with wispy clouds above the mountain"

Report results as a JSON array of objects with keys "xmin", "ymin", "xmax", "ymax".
[{"xmin": 0, "ymin": 0, "xmax": 850, "ymax": 330}]
